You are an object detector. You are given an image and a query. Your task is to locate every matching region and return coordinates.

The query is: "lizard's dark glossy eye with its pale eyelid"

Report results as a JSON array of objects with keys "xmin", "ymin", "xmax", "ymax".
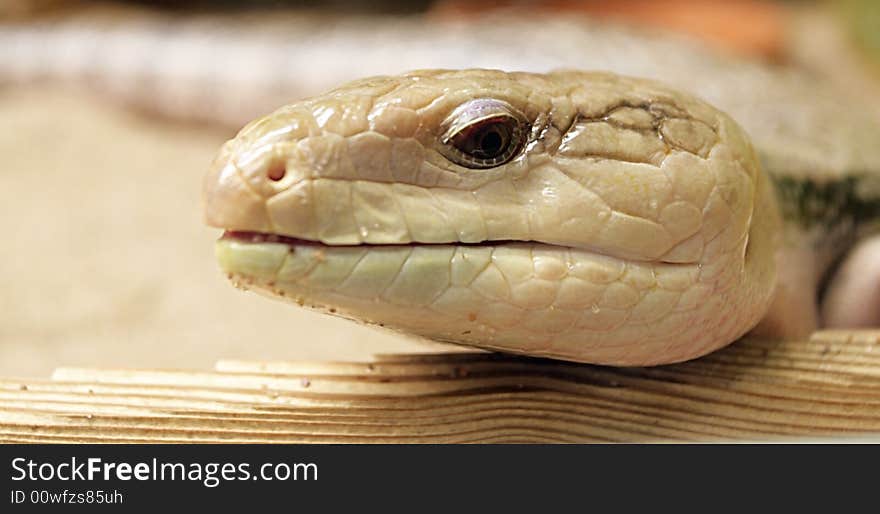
[{"xmin": 440, "ymin": 98, "xmax": 528, "ymax": 169}]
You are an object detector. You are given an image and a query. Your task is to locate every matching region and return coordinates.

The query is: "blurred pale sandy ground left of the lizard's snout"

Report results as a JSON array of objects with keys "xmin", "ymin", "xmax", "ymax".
[{"xmin": 0, "ymin": 87, "xmax": 440, "ymax": 377}]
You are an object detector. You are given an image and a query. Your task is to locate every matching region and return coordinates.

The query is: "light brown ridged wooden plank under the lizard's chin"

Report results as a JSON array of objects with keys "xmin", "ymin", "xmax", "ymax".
[{"xmin": 0, "ymin": 330, "xmax": 880, "ymax": 443}]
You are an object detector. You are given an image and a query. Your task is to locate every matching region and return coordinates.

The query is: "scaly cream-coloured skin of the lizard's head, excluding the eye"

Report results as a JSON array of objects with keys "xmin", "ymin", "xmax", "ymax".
[{"xmin": 205, "ymin": 70, "xmax": 778, "ymax": 365}]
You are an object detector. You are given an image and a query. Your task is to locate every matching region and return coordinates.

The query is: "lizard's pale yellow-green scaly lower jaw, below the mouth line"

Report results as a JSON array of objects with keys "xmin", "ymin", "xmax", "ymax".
[{"xmin": 216, "ymin": 232, "xmax": 748, "ymax": 365}]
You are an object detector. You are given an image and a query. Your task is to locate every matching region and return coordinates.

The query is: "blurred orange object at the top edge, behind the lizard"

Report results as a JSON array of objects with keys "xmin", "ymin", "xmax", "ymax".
[{"xmin": 432, "ymin": 0, "xmax": 788, "ymax": 60}]
